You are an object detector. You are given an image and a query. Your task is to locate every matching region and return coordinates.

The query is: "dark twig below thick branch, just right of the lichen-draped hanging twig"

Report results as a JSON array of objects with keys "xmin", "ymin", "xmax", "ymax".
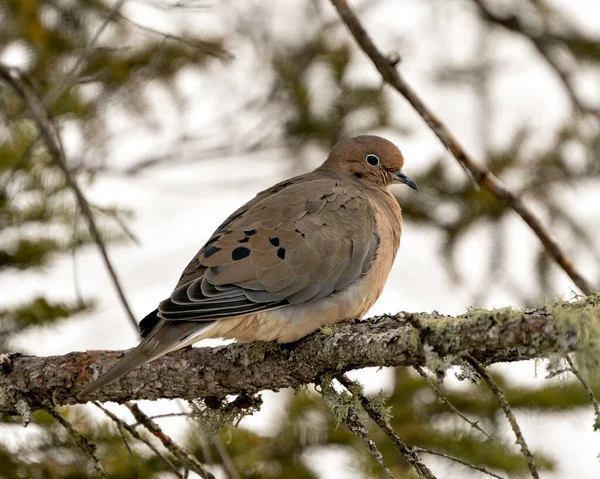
[{"xmin": 337, "ymin": 374, "xmax": 436, "ymax": 479}]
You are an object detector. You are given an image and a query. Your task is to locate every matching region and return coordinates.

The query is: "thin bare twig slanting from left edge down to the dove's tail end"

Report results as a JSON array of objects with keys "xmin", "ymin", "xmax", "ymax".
[{"xmin": 0, "ymin": 65, "xmax": 138, "ymax": 331}]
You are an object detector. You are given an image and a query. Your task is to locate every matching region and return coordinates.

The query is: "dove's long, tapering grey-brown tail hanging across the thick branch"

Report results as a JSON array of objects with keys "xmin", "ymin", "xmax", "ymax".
[{"xmin": 77, "ymin": 321, "xmax": 213, "ymax": 400}]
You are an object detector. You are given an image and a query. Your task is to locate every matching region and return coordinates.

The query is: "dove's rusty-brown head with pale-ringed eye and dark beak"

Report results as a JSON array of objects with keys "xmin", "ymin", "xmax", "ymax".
[{"xmin": 322, "ymin": 135, "xmax": 418, "ymax": 190}]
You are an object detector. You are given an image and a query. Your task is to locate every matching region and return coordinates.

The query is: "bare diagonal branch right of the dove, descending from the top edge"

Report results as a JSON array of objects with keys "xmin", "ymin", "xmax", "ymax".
[{"xmin": 331, "ymin": 0, "xmax": 595, "ymax": 296}]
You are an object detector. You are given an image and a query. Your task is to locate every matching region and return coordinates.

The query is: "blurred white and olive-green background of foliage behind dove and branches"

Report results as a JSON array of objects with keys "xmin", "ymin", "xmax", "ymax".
[{"xmin": 0, "ymin": 0, "xmax": 600, "ymax": 479}]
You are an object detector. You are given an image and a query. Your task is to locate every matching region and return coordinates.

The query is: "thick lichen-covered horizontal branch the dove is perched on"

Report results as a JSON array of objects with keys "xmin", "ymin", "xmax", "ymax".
[{"xmin": 0, "ymin": 294, "xmax": 600, "ymax": 414}]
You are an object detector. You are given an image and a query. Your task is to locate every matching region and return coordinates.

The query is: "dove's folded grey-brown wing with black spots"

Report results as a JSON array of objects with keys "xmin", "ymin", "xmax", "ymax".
[{"xmin": 148, "ymin": 177, "xmax": 378, "ymax": 334}]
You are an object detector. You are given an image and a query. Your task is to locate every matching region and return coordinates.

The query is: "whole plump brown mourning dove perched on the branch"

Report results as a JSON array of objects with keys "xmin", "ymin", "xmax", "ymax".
[{"xmin": 78, "ymin": 135, "xmax": 418, "ymax": 399}]
